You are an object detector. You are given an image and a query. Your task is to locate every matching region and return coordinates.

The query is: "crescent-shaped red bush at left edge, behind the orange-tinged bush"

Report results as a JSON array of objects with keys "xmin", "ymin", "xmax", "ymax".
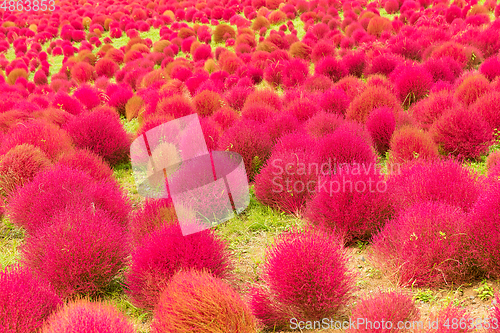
[{"xmin": 0, "ymin": 119, "xmax": 72, "ymax": 160}]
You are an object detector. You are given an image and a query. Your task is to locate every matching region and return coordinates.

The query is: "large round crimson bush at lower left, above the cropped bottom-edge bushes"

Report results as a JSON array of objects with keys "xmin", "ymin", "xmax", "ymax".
[{"xmin": 22, "ymin": 205, "xmax": 128, "ymax": 297}]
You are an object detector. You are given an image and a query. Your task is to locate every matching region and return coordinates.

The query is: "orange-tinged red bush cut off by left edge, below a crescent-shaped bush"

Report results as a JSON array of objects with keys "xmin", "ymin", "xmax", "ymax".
[{"xmin": 0, "ymin": 144, "xmax": 51, "ymax": 197}]
